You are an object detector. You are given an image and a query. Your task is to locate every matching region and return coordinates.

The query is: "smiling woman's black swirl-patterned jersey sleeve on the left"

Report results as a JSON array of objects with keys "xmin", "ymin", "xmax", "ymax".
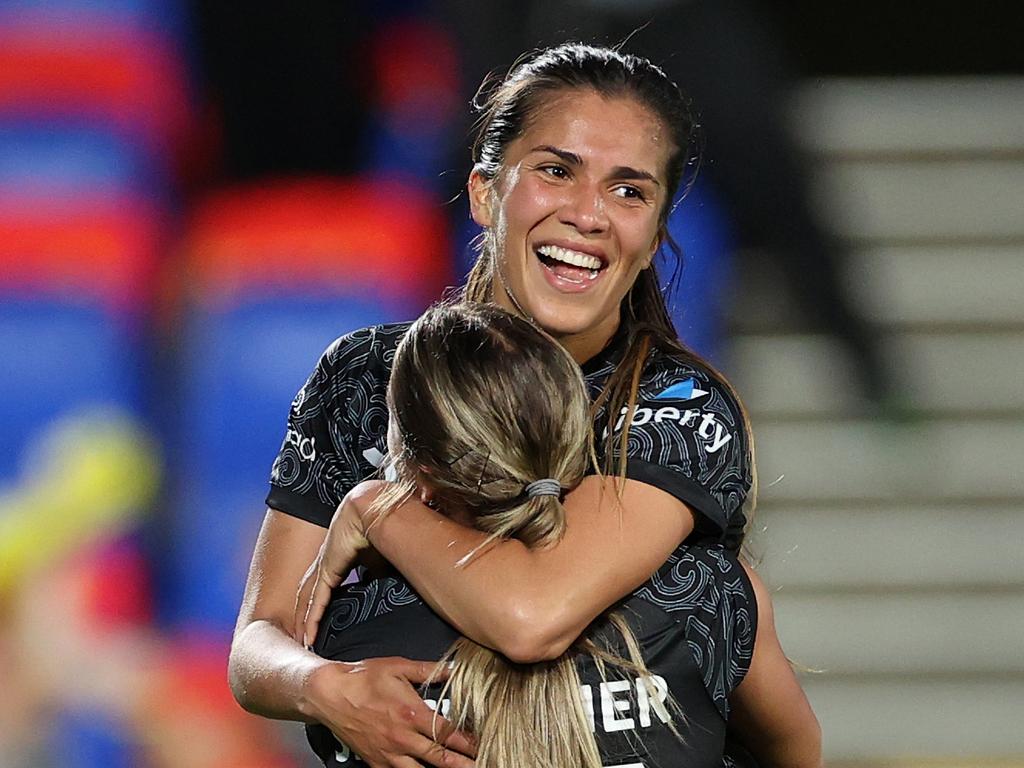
[{"xmin": 266, "ymin": 329, "xmax": 386, "ymax": 527}]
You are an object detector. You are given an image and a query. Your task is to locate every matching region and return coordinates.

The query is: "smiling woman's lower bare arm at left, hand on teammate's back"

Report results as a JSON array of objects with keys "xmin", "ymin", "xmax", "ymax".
[{"xmin": 228, "ymin": 510, "xmax": 472, "ymax": 768}]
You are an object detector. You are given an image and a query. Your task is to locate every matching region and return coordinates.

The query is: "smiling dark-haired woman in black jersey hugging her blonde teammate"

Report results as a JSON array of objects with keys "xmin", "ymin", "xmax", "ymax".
[{"xmin": 230, "ymin": 45, "xmax": 820, "ymax": 768}]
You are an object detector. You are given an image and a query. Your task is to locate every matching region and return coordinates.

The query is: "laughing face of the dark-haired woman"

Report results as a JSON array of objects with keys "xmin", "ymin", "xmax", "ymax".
[{"xmin": 469, "ymin": 89, "xmax": 674, "ymax": 361}]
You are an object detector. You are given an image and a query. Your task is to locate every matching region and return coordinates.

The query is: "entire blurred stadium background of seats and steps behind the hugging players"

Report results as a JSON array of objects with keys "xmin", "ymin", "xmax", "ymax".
[{"xmin": 0, "ymin": 0, "xmax": 1024, "ymax": 768}]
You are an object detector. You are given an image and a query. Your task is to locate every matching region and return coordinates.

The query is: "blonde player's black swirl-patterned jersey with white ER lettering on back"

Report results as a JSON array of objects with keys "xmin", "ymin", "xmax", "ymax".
[{"xmin": 307, "ymin": 545, "xmax": 757, "ymax": 768}]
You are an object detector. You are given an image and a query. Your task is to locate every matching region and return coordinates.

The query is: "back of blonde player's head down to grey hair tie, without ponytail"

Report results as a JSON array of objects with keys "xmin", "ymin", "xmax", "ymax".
[{"xmin": 388, "ymin": 304, "xmax": 591, "ymax": 546}]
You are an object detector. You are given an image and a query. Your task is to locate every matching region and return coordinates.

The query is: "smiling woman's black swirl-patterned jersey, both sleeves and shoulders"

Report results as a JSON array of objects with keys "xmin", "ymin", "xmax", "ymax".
[{"xmin": 267, "ymin": 324, "xmax": 751, "ymax": 549}]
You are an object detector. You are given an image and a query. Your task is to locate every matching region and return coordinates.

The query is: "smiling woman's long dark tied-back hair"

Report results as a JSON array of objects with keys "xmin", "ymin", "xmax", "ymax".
[{"xmin": 463, "ymin": 43, "xmax": 756, "ymax": 524}]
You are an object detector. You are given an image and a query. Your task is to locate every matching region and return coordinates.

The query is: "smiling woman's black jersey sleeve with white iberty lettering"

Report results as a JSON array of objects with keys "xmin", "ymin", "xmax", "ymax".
[{"xmin": 614, "ymin": 366, "xmax": 752, "ymax": 543}]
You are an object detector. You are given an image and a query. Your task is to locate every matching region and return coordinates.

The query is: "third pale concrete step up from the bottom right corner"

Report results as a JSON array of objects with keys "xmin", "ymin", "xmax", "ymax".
[{"xmin": 748, "ymin": 500, "xmax": 1024, "ymax": 589}]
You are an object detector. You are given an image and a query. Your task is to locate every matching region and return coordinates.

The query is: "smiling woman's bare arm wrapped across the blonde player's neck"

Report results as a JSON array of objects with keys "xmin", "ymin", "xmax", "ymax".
[{"xmin": 304, "ymin": 476, "xmax": 693, "ymax": 663}]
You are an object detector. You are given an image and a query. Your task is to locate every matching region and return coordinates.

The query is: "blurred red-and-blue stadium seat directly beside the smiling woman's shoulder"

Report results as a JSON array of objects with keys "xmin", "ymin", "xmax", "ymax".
[{"xmin": 168, "ymin": 179, "xmax": 451, "ymax": 637}]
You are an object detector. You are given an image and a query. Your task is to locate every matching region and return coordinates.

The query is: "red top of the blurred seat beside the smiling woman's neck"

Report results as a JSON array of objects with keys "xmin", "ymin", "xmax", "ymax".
[{"xmin": 185, "ymin": 179, "xmax": 452, "ymax": 305}]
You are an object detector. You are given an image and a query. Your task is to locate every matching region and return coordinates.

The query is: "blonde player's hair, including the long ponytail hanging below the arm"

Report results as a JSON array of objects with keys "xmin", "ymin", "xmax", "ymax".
[{"xmin": 381, "ymin": 303, "xmax": 671, "ymax": 768}]
